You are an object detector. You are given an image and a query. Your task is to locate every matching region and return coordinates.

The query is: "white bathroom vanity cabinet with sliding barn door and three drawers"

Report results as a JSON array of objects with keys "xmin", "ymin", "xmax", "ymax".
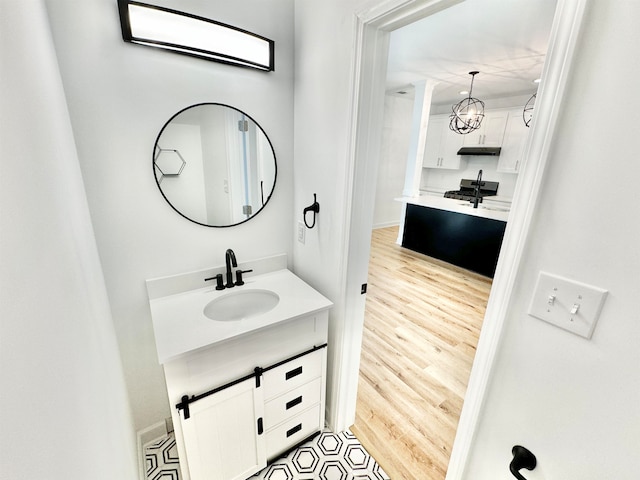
[{"xmin": 164, "ymin": 310, "xmax": 328, "ymax": 480}]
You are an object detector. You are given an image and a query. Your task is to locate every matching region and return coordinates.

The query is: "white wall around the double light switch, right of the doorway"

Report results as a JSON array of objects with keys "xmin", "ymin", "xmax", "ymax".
[{"xmin": 465, "ymin": 0, "xmax": 640, "ymax": 480}]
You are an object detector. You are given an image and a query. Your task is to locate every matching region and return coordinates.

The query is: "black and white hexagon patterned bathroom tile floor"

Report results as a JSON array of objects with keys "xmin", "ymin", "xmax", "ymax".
[{"xmin": 145, "ymin": 431, "xmax": 389, "ymax": 480}]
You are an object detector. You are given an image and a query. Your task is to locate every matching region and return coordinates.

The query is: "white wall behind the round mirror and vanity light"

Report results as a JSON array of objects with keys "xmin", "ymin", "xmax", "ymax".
[{"xmin": 46, "ymin": 0, "xmax": 293, "ymax": 429}]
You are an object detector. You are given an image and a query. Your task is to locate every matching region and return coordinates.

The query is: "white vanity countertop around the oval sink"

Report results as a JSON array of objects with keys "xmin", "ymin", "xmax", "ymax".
[{"xmin": 149, "ymin": 269, "xmax": 333, "ymax": 363}]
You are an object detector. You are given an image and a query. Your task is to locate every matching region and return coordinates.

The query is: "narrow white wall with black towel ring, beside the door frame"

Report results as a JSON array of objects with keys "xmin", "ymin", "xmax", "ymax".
[{"xmin": 293, "ymin": 0, "xmax": 367, "ymax": 424}]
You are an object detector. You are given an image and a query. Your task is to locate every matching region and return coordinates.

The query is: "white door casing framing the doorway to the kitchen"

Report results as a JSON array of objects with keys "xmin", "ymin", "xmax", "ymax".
[{"xmin": 338, "ymin": 0, "xmax": 584, "ymax": 479}]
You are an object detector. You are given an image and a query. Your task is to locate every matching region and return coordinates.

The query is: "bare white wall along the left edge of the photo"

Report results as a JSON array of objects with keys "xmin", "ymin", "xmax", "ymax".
[{"xmin": 0, "ymin": 0, "xmax": 137, "ymax": 480}]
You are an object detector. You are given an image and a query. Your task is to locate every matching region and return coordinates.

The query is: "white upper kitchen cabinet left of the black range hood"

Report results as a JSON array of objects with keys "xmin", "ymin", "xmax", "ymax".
[{"xmin": 422, "ymin": 115, "xmax": 466, "ymax": 170}]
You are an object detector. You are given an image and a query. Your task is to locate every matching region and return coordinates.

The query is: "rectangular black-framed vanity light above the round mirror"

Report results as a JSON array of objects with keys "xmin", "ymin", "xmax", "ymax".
[{"xmin": 118, "ymin": 0, "xmax": 275, "ymax": 71}]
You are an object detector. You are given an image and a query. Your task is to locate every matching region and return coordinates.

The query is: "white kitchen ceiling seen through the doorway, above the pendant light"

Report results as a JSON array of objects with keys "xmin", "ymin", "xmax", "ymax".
[{"xmin": 386, "ymin": 0, "xmax": 556, "ymax": 104}]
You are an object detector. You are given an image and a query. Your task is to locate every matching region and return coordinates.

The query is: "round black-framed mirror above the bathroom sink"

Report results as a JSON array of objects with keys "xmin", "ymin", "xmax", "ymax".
[{"xmin": 153, "ymin": 103, "xmax": 277, "ymax": 227}]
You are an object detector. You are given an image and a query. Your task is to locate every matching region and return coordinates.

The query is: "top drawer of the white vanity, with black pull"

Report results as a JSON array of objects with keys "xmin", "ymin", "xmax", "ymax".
[{"xmin": 263, "ymin": 349, "xmax": 325, "ymax": 400}]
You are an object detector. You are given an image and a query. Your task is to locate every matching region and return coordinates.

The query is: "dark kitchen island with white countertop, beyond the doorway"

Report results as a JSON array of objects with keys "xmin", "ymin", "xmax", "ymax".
[{"xmin": 402, "ymin": 197, "xmax": 509, "ymax": 278}]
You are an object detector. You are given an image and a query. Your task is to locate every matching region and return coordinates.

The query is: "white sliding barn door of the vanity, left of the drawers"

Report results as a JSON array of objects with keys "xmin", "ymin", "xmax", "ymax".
[{"xmin": 180, "ymin": 378, "xmax": 267, "ymax": 480}]
